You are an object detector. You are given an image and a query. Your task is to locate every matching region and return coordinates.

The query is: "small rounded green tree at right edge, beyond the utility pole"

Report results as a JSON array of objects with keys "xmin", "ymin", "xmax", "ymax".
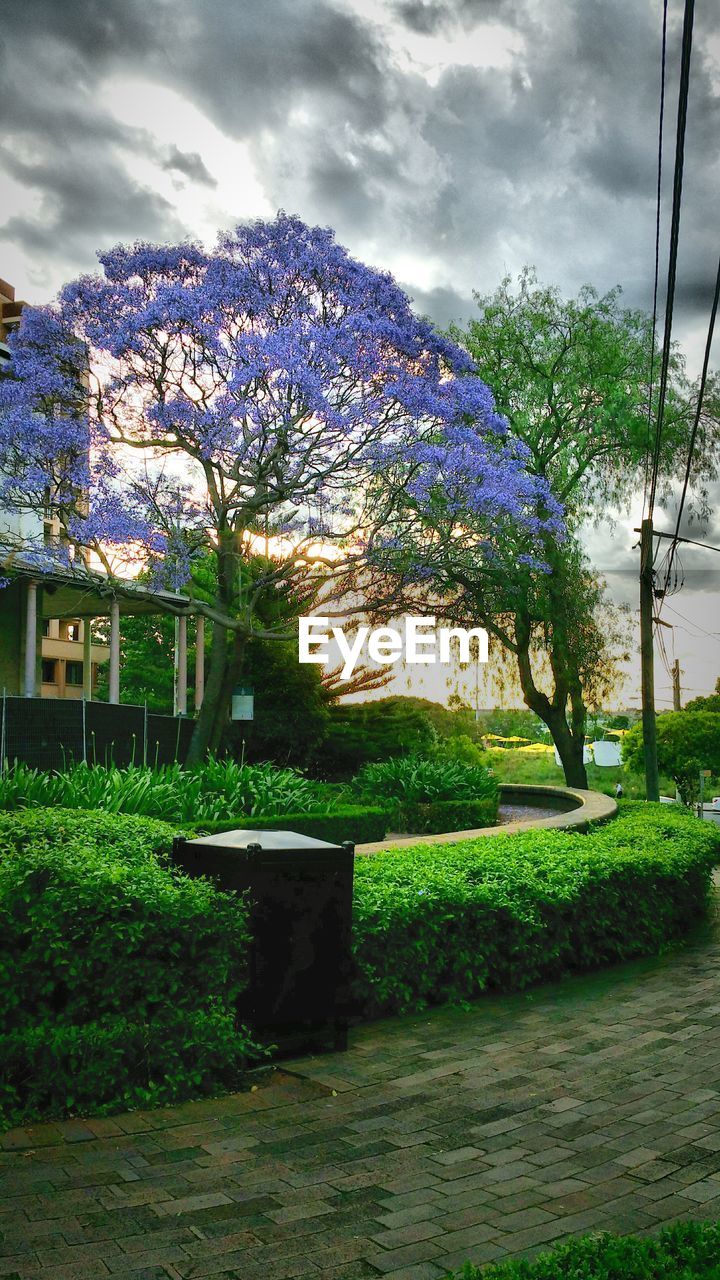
[{"xmin": 623, "ymin": 710, "xmax": 720, "ymax": 805}]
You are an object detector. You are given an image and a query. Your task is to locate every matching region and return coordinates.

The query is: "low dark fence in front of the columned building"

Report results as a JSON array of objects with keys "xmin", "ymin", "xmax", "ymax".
[{"xmin": 0, "ymin": 694, "xmax": 193, "ymax": 769}]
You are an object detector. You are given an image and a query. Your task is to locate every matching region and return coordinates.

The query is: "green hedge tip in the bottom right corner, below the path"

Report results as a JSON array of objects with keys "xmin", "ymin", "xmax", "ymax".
[{"xmin": 457, "ymin": 1222, "xmax": 720, "ymax": 1280}]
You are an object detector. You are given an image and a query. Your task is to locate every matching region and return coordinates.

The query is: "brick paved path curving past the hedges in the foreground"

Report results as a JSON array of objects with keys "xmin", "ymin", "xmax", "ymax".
[{"xmin": 0, "ymin": 911, "xmax": 720, "ymax": 1280}]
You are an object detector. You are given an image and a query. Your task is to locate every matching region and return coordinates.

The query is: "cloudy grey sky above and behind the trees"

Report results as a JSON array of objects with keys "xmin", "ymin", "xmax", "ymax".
[{"xmin": 0, "ymin": 0, "xmax": 720, "ymax": 705}]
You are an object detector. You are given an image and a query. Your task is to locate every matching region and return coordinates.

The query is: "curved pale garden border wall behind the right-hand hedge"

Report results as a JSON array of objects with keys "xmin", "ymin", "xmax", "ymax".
[{"xmin": 355, "ymin": 782, "xmax": 618, "ymax": 854}]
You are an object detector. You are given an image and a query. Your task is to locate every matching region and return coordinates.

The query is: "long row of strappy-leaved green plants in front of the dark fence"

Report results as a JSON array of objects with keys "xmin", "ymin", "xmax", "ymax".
[{"xmin": 0, "ymin": 760, "xmax": 324, "ymax": 822}]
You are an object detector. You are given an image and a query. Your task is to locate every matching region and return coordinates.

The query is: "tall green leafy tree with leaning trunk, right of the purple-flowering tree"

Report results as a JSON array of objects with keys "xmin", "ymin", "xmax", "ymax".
[{"xmin": 366, "ymin": 268, "xmax": 720, "ymax": 786}]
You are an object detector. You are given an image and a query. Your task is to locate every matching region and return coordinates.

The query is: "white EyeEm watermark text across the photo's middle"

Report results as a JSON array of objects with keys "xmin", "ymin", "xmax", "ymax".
[{"xmin": 299, "ymin": 617, "xmax": 488, "ymax": 680}]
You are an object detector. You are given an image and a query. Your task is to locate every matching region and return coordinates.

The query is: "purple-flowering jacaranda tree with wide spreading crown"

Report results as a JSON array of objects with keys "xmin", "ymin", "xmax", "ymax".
[{"xmin": 0, "ymin": 214, "xmax": 556, "ymax": 760}]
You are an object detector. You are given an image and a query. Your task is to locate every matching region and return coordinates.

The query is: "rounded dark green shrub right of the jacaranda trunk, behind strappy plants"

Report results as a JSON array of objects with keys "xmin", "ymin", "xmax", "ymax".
[{"xmin": 318, "ymin": 698, "xmax": 437, "ymax": 778}]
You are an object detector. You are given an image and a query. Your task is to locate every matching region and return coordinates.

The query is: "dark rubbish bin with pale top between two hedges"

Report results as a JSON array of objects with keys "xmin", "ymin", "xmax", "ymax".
[{"xmin": 173, "ymin": 831, "xmax": 354, "ymax": 1052}]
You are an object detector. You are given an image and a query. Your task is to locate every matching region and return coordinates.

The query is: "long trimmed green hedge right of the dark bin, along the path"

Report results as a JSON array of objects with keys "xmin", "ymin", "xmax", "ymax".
[{"xmin": 354, "ymin": 803, "xmax": 720, "ymax": 1015}]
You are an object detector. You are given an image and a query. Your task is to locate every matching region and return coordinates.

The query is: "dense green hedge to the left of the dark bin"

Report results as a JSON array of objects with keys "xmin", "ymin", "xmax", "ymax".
[{"xmin": 0, "ymin": 809, "xmax": 251, "ymax": 1119}]
